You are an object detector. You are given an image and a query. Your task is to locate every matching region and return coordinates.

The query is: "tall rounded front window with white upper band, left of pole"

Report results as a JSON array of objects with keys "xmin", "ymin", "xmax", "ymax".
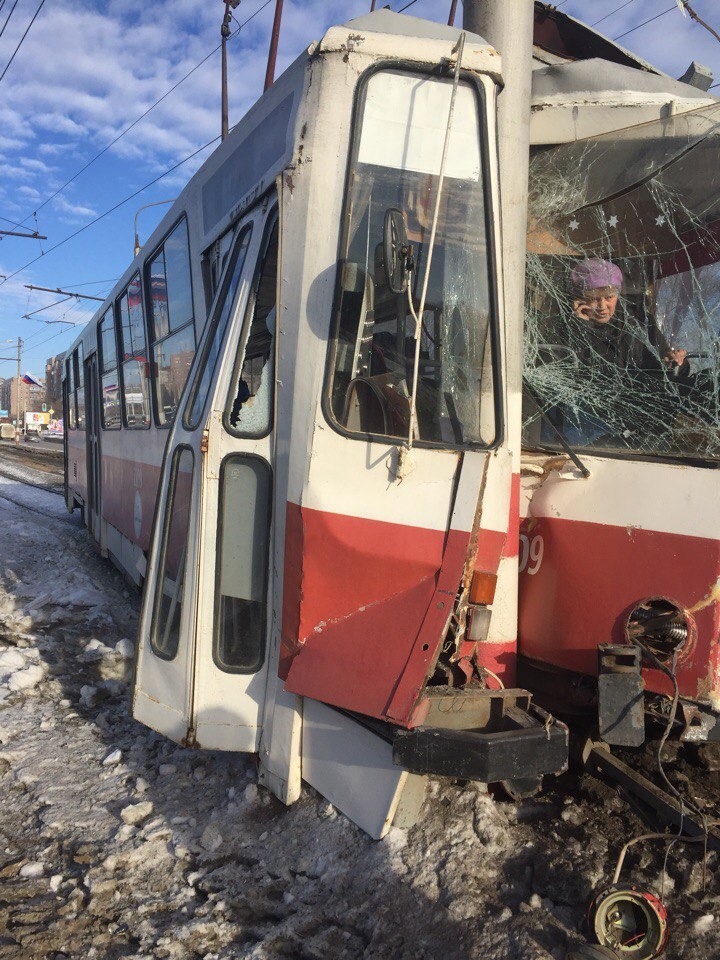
[{"xmin": 327, "ymin": 70, "xmax": 498, "ymax": 447}]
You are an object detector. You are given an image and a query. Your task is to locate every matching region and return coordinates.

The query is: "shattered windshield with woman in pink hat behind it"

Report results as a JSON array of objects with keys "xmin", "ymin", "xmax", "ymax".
[{"xmin": 523, "ymin": 101, "xmax": 720, "ymax": 461}]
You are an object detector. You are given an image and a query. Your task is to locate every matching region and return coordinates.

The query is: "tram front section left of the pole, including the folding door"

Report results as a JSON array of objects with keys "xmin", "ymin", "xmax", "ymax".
[{"xmin": 135, "ymin": 11, "xmax": 567, "ymax": 836}]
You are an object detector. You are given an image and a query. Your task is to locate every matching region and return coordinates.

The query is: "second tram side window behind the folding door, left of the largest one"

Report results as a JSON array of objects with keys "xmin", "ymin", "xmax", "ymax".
[{"xmin": 117, "ymin": 273, "xmax": 150, "ymax": 428}]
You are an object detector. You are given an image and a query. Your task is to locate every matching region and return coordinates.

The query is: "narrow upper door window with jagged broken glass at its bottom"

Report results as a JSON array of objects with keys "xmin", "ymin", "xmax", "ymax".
[{"xmin": 228, "ymin": 219, "xmax": 278, "ymax": 437}]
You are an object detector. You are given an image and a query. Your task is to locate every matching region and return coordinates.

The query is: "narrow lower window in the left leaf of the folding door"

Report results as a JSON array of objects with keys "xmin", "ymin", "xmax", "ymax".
[{"xmin": 151, "ymin": 447, "xmax": 194, "ymax": 660}]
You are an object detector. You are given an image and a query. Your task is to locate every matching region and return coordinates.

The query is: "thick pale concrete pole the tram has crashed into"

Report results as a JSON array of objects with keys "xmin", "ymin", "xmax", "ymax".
[{"xmin": 463, "ymin": 0, "xmax": 534, "ymax": 681}]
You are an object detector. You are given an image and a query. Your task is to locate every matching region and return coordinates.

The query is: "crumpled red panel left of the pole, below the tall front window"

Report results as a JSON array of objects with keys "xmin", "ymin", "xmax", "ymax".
[{"xmin": 280, "ymin": 503, "xmax": 500, "ymax": 723}]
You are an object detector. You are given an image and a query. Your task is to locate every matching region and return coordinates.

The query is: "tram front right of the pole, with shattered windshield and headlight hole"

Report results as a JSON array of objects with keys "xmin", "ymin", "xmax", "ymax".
[{"xmin": 519, "ymin": 65, "xmax": 720, "ymax": 746}]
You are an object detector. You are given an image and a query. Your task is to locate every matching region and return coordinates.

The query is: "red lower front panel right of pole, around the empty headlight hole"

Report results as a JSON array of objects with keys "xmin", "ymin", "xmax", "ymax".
[{"xmin": 520, "ymin": 517, "xmax": 720, "ymax": 697}]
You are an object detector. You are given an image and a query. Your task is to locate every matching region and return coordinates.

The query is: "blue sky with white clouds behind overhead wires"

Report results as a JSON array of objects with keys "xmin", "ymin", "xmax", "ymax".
[{"xmin": 0, "ymin": 0, "xmax": 720, "ymax": 377}]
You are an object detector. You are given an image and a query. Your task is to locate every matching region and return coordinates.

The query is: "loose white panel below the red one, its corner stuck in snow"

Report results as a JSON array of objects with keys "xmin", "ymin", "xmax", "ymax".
[{"xmin": 302, "ymin": 698, "xmax": 407, "ymax": 840}]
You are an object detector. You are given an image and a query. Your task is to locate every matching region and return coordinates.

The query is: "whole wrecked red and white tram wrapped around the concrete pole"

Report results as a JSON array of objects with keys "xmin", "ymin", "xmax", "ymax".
[{"xmin": 65, "ymin": 5, "xmax": 720, "ymax": 836}]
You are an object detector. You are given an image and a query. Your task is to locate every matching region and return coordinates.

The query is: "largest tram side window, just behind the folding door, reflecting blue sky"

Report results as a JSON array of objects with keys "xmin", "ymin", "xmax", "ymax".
[{"xmin": 147, "ymin": 219, "xmax": 195, "ymax": 425}]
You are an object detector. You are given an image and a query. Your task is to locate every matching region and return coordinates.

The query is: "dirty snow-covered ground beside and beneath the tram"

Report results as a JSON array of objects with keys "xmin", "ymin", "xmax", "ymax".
[{"xmin": 0, "ymin": 460, "xmax": 720, "ymax": 960}]
